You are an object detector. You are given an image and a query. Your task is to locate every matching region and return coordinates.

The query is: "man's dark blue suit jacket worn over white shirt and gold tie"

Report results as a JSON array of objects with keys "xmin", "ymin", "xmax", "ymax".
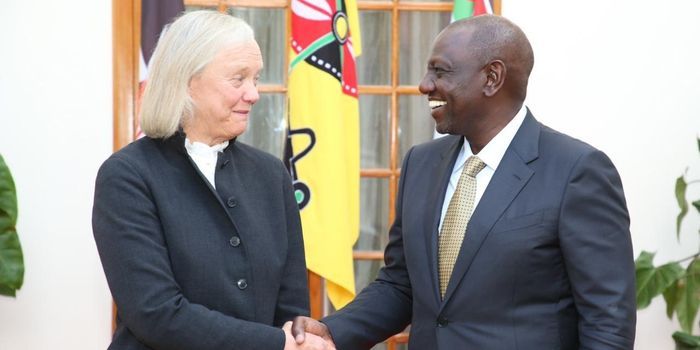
[{"xmin": 323, "ymin": 112, "xmax": 636, "ymax": 350}]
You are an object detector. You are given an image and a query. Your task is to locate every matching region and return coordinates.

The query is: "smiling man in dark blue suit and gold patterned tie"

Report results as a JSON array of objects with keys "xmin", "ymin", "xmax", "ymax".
[{"xmin": 293, "ymin": 16, "xmax": 635, "ymax": 350}]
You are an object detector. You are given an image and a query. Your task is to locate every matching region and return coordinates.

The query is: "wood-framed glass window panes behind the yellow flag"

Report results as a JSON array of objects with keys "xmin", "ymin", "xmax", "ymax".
[{"xmin": 120, "ymin": 0, "xmax": 500, "ymax": 350}]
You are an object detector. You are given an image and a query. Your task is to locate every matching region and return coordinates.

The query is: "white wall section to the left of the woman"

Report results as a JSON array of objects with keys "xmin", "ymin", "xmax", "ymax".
[{"xmin": 0, "ymin": 0, "xmax": 112, "ymax": 350}]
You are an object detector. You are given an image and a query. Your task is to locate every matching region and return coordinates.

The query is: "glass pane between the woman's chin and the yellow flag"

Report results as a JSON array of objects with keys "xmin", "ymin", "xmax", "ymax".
[{"xmin": 240, "ymin": 94, "xmax": 287, "ymax": 159}]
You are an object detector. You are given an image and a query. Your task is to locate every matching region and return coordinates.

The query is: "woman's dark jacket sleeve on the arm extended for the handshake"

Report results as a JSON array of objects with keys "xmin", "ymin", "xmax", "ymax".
[{"xmin": 92, "ymin": 156, "xmax": 284, "ymax": 350}]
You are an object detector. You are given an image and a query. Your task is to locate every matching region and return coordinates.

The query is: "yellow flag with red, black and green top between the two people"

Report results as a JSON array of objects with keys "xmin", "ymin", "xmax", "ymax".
[{"xmin": 285, "ymin": 0, "xmax": 360, "ymax": 308}]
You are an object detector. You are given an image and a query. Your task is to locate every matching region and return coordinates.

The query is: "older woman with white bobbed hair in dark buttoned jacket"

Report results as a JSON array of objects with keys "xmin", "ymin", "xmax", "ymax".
[{"xmin": 93, "ymin": 11, "xmax": 323, "ymax": 350}]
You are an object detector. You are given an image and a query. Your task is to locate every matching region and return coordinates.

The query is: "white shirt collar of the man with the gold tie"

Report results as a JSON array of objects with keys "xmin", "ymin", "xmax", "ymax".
[{"xmin": 455, "ymin": 104, "xmax": 527, "ymax": 171}]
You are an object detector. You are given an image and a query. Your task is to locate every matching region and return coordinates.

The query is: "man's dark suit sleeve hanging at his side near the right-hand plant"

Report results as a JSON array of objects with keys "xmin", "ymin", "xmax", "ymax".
[{"xmin": 559, "ymin": 151, "xmax": 636, "ymax": 350}]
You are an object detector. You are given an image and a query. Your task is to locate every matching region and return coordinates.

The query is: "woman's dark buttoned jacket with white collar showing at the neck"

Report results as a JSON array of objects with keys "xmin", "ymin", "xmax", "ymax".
[{"xmin": 92, "ymin": 133, "xmax": 309, "ymax": 349}]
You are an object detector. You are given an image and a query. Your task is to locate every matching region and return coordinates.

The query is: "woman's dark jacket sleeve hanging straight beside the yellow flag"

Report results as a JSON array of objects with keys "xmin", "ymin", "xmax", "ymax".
[{"xmin": 275, "ymin": 163, "xmax": 309, "ymax": 327}]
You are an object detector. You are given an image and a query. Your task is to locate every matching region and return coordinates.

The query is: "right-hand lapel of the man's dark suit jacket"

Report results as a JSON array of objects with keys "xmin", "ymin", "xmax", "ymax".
[{"xmin": 442, "ymin": 111, "xmax": 540, "ymax": 307}]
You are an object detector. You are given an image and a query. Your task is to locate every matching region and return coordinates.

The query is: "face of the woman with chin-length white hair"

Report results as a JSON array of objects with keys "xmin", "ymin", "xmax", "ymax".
[{"xmin": 183, "ymin": 41, "xmax": 263, "ymax": 145}]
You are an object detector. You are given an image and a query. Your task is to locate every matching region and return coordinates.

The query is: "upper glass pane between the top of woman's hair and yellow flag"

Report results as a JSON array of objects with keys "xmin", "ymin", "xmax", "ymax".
[{"xmin": 228, "ymin": 7, "xmax": 287, "ymax": 84}]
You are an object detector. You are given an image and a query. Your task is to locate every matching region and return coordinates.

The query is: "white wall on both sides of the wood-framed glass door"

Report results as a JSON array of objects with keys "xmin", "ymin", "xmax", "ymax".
[{"xmin": 0, "ymin": 0, "xmax": 700, "ymax": 350}]
